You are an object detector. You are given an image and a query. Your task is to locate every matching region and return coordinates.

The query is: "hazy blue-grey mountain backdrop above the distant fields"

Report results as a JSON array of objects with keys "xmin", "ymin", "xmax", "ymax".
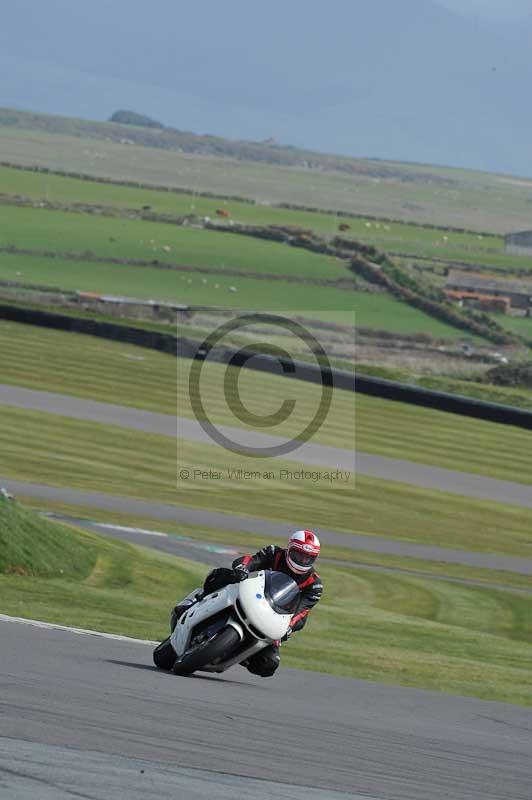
[{"xmin": 0, "ymin": 0, "xmax": 532, "ymax": 175}]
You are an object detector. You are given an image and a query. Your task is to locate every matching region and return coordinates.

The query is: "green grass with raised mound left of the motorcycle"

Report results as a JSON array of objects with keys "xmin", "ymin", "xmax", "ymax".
[{"xmin": 0, "ymin": 500, "xmax": 205, "ymax": 638}]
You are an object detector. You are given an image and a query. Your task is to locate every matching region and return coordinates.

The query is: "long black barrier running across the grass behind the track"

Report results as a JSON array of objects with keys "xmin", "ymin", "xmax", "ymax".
[{"xmin": 4, "ymin": 305, "xmax": 532, "ymax": 430}]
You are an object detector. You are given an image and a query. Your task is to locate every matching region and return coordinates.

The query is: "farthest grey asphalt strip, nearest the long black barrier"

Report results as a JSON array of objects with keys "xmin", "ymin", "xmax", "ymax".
[{"xmin": 0, "ymin": 384, "xmax": 532, "ymax": 508}]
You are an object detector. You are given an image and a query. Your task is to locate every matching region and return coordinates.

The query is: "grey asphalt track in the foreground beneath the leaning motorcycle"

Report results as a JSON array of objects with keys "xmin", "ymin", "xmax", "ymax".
[{"xmin": 0, "ymin": 621, "xmax": 532, "ymax": 800}]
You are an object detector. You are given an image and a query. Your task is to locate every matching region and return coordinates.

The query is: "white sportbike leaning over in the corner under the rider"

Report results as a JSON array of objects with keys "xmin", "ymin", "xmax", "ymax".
[{"xmin": 153, "ymin": 570, "xmax": 300, "ymax": 675}]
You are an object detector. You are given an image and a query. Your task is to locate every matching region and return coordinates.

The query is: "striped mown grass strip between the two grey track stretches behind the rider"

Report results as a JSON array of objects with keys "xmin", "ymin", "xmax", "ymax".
[{"xmin": 5, "ymin": 406, "xmax": 532, "ymax": 558}]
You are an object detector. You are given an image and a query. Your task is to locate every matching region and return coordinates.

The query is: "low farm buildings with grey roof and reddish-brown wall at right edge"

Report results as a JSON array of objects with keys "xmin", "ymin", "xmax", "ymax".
[{"xmin": 445, "ymin": 272, "xmax": 532, "ymax": 317}]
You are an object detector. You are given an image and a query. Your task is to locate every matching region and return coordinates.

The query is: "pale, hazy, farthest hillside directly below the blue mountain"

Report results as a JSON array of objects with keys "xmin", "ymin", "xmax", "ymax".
[{"xmin": 0, "ymin": 109, "xmax": 532, "ymax": 233}]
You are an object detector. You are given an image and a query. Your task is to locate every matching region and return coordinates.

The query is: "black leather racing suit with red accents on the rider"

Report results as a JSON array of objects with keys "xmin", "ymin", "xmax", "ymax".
[{"xmin": 233, "ymin": 544, "xmax": 323, "ymax": 678}]
